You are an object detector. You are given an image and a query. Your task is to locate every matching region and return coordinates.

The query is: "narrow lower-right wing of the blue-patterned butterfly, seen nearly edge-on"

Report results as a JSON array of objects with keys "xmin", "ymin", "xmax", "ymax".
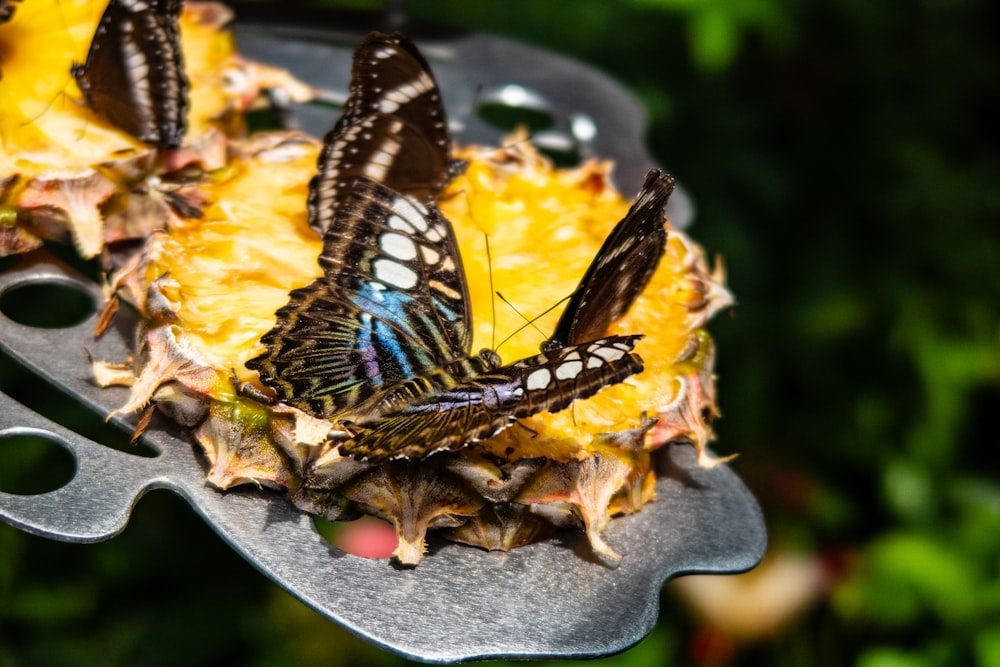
[{"xmin": 341, "ymin": 336, "xmax": 643, "ymax": 461}]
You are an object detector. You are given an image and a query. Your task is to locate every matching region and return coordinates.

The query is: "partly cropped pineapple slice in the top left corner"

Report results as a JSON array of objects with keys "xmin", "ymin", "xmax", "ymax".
[{"xmin": 0, "ymin": 0, "xmax": 274, "ymax": 257}]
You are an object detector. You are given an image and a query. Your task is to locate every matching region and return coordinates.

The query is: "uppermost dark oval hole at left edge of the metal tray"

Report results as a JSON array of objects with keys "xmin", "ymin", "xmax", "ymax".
[{"xmin": 0, "ymin": 282, "xmax": 97, "ymax": 329}]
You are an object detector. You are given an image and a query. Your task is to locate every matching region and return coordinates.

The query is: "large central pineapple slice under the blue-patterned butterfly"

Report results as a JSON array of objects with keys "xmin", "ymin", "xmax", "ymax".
[{"xmin": 95, "ymin": 134, "xmax": 732, "ymax": 565}]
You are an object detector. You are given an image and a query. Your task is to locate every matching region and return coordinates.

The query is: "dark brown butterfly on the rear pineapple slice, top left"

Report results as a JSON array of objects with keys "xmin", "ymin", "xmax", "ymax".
[{"xmin": 71, "ymin": 0, "xmax": 188, "ymax": 148}]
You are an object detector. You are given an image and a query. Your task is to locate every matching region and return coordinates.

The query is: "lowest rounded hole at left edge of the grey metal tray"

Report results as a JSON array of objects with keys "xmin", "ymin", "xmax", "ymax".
[{"xmin": 0, "ymin": 432, "xmax": 76, "ymax": 496}]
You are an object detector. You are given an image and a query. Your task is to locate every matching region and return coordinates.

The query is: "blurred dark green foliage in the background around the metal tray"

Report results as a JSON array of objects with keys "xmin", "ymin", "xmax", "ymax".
[{"xmin": 0, "ymin": 0, "xmax": 1000, "ymax": 667}]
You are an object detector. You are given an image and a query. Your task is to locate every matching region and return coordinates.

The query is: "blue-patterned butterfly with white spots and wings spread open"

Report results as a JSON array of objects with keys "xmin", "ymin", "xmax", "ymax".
[{"xmin": 247, "ymin": 178, "xmax": 642, "ymax": 461}]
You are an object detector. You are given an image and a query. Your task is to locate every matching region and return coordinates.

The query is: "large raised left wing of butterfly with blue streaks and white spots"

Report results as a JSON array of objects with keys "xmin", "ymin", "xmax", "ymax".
[{"xmin": 247, "ymin": 178, "xmax": 472, "ymax": 417}]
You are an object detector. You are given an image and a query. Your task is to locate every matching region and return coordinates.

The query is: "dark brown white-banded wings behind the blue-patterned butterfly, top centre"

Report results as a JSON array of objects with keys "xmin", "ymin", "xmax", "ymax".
[{"xmin": 308, "ymin": 33, "xmax": 462, "ymax": 239}]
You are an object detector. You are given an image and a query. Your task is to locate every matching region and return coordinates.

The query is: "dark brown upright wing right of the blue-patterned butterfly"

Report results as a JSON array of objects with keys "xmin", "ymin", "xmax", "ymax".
[{"xmin": 547, "ymin": 169, "xmax": 674, "ymax": 349}]
